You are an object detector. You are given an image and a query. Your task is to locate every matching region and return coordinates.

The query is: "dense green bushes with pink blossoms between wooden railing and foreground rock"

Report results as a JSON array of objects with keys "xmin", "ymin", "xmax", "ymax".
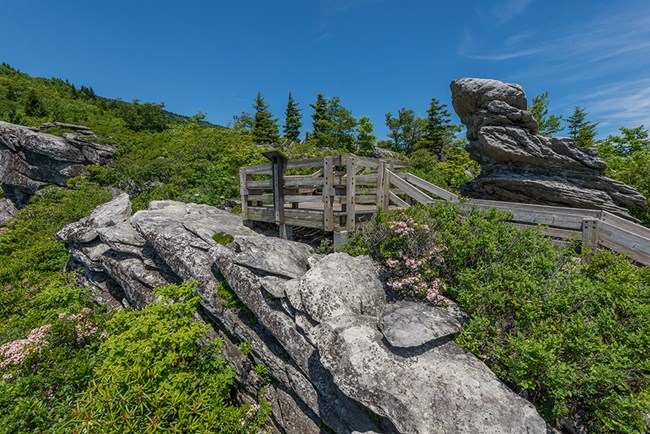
[{"xmin": 347, "ymin": 204, "xmax": 650, "ymax": 433}]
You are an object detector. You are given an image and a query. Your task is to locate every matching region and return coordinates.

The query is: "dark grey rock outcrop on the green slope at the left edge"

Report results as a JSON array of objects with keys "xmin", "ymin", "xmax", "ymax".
[{"xmin": 0, "ymin": 122, "xmax": 115, "ymax": 208}]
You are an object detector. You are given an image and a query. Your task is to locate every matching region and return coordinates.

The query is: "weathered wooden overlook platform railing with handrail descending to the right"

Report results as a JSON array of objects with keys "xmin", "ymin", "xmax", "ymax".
[{"xmin": 240, "ymin": 154, "xmax": 650, "ymax": 265}]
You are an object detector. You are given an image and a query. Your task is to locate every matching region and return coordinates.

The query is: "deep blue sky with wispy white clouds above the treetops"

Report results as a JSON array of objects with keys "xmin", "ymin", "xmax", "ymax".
[{"xmin": 0, "ymin": 0, "xmax": 650, "ymax": 138}]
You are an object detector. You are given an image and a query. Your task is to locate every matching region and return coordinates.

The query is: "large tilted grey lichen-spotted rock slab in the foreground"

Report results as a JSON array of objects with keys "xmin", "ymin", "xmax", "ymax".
[{"xmin": 57, "ymin": 194, "xmax": 547, "ymax": 434}]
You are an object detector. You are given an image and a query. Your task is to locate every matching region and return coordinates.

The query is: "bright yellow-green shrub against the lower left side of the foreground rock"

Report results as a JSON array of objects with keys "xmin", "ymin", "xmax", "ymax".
[{"xmin": 66, "ymin": 283, "xmax": 270, "ymax": 433}]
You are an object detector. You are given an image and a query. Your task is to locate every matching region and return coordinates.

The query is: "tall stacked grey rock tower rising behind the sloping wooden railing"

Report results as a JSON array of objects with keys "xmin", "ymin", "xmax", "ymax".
[{"xmin": 450, "ymin": 78, "xmax": 646, "ymax": 218}]
